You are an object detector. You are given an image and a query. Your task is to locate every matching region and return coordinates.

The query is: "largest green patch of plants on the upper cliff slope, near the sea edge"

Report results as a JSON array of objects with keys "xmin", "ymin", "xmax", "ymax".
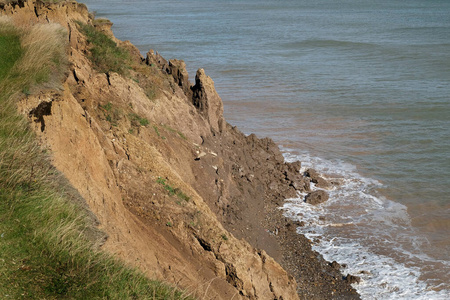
[{"xmin": 78, "ymin": 22, "xmax": 131, "ymax": 74}]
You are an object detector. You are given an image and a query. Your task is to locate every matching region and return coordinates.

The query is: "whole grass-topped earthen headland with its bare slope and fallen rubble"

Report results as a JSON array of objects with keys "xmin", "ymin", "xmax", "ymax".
[{"xmin": 0, "ymin": 0, "xmax": 362, "ymax": 300}]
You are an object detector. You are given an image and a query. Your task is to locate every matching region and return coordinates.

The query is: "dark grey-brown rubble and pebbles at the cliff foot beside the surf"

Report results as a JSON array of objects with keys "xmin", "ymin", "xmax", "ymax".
[{"xmin": 198, "ymin": 125, "xmax": 360, "ymax": 299}]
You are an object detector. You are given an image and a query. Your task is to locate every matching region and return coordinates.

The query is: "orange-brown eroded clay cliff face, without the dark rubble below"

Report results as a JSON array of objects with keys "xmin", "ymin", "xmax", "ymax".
[{"xmin": 3, "ymin": 1, "xmax": 297, "ymax": 299}]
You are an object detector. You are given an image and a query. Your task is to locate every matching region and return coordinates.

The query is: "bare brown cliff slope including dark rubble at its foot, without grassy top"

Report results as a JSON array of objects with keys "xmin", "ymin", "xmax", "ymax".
[{"xmin": 0, "ymin": 0, "xmax": 357, "ymax": 299}]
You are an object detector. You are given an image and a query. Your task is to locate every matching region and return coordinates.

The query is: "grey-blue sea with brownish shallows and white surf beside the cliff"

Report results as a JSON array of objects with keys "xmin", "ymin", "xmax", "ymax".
[{"xmin": 84, "ymin": 0, "xmax": 450, "ymax": 299}]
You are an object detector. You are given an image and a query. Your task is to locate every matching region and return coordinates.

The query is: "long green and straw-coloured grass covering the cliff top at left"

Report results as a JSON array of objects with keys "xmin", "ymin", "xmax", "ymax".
[{"xmin": 0, "ymin": 19, "xmax": 195, "ymax": 299}]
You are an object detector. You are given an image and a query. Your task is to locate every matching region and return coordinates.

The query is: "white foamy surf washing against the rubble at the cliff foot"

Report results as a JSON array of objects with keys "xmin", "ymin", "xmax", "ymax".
[{"xmin": 282, "ymin": 153, "xmax": 450, "ymax": 300}]
